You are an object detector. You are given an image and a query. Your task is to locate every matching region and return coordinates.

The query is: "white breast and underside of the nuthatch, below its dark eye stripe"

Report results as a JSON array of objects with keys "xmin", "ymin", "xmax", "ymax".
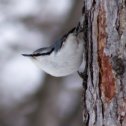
[{"xmin": 33, "ymin": 34, "xmax": 84, "ymax": 77}]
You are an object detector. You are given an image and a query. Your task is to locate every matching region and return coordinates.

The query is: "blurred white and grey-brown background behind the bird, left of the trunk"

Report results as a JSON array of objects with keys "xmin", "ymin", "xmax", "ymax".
[{"xmin": 0, "ymin": 0, "xmax": 83, "ymax": 126}]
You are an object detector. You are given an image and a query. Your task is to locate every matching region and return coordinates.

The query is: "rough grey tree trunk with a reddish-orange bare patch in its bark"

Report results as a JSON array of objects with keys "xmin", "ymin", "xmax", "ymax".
[{"xmin": 83, "ymin": 0, "xmax": 126, "ymax": 126}]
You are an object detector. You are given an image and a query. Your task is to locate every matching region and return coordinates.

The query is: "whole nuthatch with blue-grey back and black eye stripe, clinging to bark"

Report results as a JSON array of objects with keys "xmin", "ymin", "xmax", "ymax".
[{"xmin": 22, "ymin": 24, "xmax": 84, "ymax": 77}]
